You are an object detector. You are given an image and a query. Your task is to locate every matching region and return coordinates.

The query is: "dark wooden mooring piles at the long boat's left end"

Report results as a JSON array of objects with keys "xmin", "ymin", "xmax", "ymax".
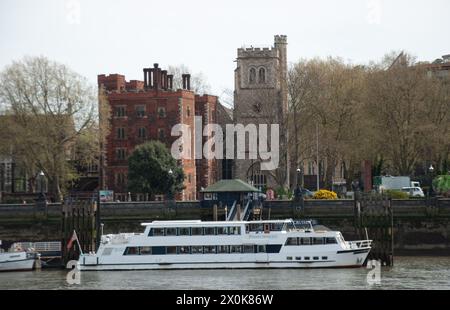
[{"xmin": 61, "ymin": 196, "xmax": 97, "ymax": 266}]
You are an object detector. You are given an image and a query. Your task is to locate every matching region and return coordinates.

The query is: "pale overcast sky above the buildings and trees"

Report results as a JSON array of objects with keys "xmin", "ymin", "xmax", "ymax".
[{"xmin": 0, "ymin": 0, "xmax": 450, "ymax": 99}]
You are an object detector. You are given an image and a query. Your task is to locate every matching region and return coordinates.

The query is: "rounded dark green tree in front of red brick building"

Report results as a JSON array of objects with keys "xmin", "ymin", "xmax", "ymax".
[{"xmin": 128, "ymin": 141, "xmax": 184, "ymax": 197}]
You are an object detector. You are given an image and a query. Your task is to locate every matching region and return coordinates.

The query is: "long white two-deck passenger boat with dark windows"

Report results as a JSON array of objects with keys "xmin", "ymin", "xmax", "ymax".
[{"xmin": 78, "ymin": 219, "xmax": 372, "ymax": 270}]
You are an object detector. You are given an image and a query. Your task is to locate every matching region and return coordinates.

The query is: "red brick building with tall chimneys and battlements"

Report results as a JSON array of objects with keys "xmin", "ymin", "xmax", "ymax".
[{"xmin": 98, "ymin": 64, "xmax": 225, "ymax": 200}]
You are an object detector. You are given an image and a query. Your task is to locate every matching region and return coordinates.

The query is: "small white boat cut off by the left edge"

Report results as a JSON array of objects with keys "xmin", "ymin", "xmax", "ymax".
[{"xmin": 0, "ymin": 242, "xmax": 40, "ymax": 271}]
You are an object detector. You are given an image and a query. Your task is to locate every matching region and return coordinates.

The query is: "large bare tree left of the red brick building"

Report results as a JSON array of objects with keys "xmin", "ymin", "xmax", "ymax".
[{"xmin": 0, "ymin": 57, "xmax": 98, "ymax": 200}]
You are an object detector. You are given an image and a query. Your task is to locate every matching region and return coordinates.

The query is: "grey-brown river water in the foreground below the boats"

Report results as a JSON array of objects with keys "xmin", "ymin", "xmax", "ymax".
[{"xmin": 0, "ymin": 257, "xmax": 450, "ymax": 290}]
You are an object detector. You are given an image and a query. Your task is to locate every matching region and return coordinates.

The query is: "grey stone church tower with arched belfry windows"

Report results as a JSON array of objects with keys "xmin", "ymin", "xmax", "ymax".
[{"xmin": 233, "ymin": 35, "xmax": 289, "ymax": 189}]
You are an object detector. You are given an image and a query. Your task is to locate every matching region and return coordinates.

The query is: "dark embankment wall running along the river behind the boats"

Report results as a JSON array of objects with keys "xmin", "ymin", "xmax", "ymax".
[{"xmin": 0, "ymin": 199, "xmax": 450, "ymax": 255}]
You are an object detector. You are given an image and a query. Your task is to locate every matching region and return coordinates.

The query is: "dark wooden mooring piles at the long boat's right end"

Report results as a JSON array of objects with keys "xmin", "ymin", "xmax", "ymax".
[{"xmin": 354, "ymin": 193, "xmax": 394, "ymax": 266}]
